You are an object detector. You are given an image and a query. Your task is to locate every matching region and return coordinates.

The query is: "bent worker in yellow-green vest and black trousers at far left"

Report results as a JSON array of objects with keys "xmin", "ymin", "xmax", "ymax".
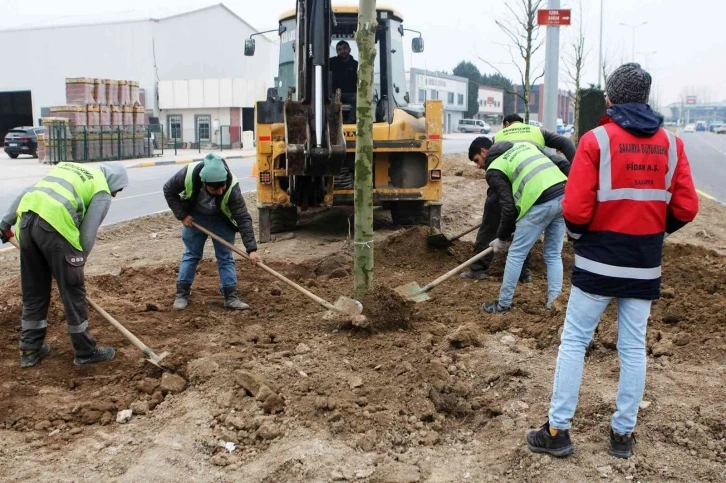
[{"xmin": 0, "ymin": 162, "xmax": 129, "ymax": 367}]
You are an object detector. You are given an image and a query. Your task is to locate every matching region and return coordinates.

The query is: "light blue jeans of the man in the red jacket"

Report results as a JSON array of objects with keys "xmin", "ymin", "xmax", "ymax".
[{"xmin": 549, "ymin": 287, "xmax": 651, "ymax": 434}]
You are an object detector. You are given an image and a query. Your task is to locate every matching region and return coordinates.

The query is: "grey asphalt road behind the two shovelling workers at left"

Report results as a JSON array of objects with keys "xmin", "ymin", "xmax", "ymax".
[{"xmin": 0, "ymin": 158, "xmax": 255, "ymax": 248}]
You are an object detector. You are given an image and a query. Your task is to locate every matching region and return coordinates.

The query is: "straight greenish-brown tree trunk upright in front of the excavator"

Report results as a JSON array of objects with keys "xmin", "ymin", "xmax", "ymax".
[{"xmin": 354, "ymin": 0, "xmax": 378, "ymax": 299}]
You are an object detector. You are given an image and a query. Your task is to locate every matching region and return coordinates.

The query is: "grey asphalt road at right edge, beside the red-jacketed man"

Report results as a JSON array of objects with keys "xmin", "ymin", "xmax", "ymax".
[{"xmin": 679, "ymin": 131, "xmax": 726, "ymax": 204}]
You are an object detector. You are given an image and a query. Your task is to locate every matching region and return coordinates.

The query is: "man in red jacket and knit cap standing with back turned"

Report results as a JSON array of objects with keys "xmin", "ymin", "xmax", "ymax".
[{"xmin": 527, "ymin": 63, "xmax": 698, "ymax": 458}]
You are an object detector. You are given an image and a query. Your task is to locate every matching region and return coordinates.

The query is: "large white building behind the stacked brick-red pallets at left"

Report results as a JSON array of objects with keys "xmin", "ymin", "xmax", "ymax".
[{"xmin": 0, "ymin": 4, "xmax": 277, "ymax": 146}]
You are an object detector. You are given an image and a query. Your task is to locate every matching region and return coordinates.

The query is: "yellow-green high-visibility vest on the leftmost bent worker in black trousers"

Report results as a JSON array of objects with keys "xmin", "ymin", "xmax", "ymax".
[{"xmin": 17, "ymin": 163, "xmax": 111, "ymax": 251}]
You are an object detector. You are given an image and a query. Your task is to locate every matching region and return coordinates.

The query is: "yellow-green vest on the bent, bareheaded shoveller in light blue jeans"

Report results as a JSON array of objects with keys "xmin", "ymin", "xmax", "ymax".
[{"xmin": 487, "ymin": 142, "xmax": 567, "ymax": 221}]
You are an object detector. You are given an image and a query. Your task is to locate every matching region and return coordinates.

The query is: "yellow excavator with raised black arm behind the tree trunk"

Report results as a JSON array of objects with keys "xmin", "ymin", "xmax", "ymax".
[{"xmin": 245, "ymin": 0, "xmax": 443, "ymax": 242}]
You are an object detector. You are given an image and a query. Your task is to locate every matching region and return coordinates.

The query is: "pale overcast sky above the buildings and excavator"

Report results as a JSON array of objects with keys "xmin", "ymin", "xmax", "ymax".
[{"xmin": 0, "ymin": 0, "xmax": 726, "ymax": 105}]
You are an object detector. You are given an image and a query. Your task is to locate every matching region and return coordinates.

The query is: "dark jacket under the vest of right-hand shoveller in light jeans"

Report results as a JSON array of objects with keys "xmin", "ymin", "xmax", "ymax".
[{"xmin": 484, "ymin": 141, "xmax": 570, "ymax": 240}]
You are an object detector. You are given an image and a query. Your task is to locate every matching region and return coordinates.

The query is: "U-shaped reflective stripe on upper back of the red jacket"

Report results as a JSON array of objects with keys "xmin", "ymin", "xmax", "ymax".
[{"xmin": 593, "ymin": 126, "xmax": 678, "ymax": 203}]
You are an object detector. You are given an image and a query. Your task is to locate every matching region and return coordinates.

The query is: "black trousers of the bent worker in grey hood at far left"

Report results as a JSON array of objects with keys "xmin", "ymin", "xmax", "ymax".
[{"xmin": 19, "ymin": 212, "xmax": 96, "ymax": 357}]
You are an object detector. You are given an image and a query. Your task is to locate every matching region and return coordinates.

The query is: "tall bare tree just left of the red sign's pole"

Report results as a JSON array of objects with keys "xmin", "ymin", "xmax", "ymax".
[{"xmin": 477, "ymin": 0, "xmax": 545, "ymax": 122}]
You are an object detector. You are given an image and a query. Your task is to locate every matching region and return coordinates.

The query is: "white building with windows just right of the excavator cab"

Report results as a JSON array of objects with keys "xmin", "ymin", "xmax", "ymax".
[{"xmin": 409, "ymin": 69, "xmax": 469, "ymax": 132}]
